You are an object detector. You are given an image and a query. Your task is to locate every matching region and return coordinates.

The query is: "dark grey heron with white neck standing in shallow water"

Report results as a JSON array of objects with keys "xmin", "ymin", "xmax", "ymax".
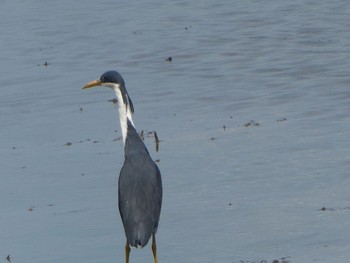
[{"xmin": 83, "ymin": 71, "xmax": 163, "ymax": 263}]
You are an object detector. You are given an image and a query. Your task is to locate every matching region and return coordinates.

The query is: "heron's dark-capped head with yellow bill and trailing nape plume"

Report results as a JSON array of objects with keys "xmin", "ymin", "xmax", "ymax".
[{"xmin": 83, "ymin": 70, "xmax": 134, "ymax": 113}]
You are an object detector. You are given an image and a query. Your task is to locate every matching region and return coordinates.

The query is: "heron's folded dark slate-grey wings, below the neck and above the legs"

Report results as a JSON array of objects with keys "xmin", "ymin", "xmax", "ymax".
[{"xmin": 118, "ymin": 154, "xmax": 162, "ymax": 247}]
